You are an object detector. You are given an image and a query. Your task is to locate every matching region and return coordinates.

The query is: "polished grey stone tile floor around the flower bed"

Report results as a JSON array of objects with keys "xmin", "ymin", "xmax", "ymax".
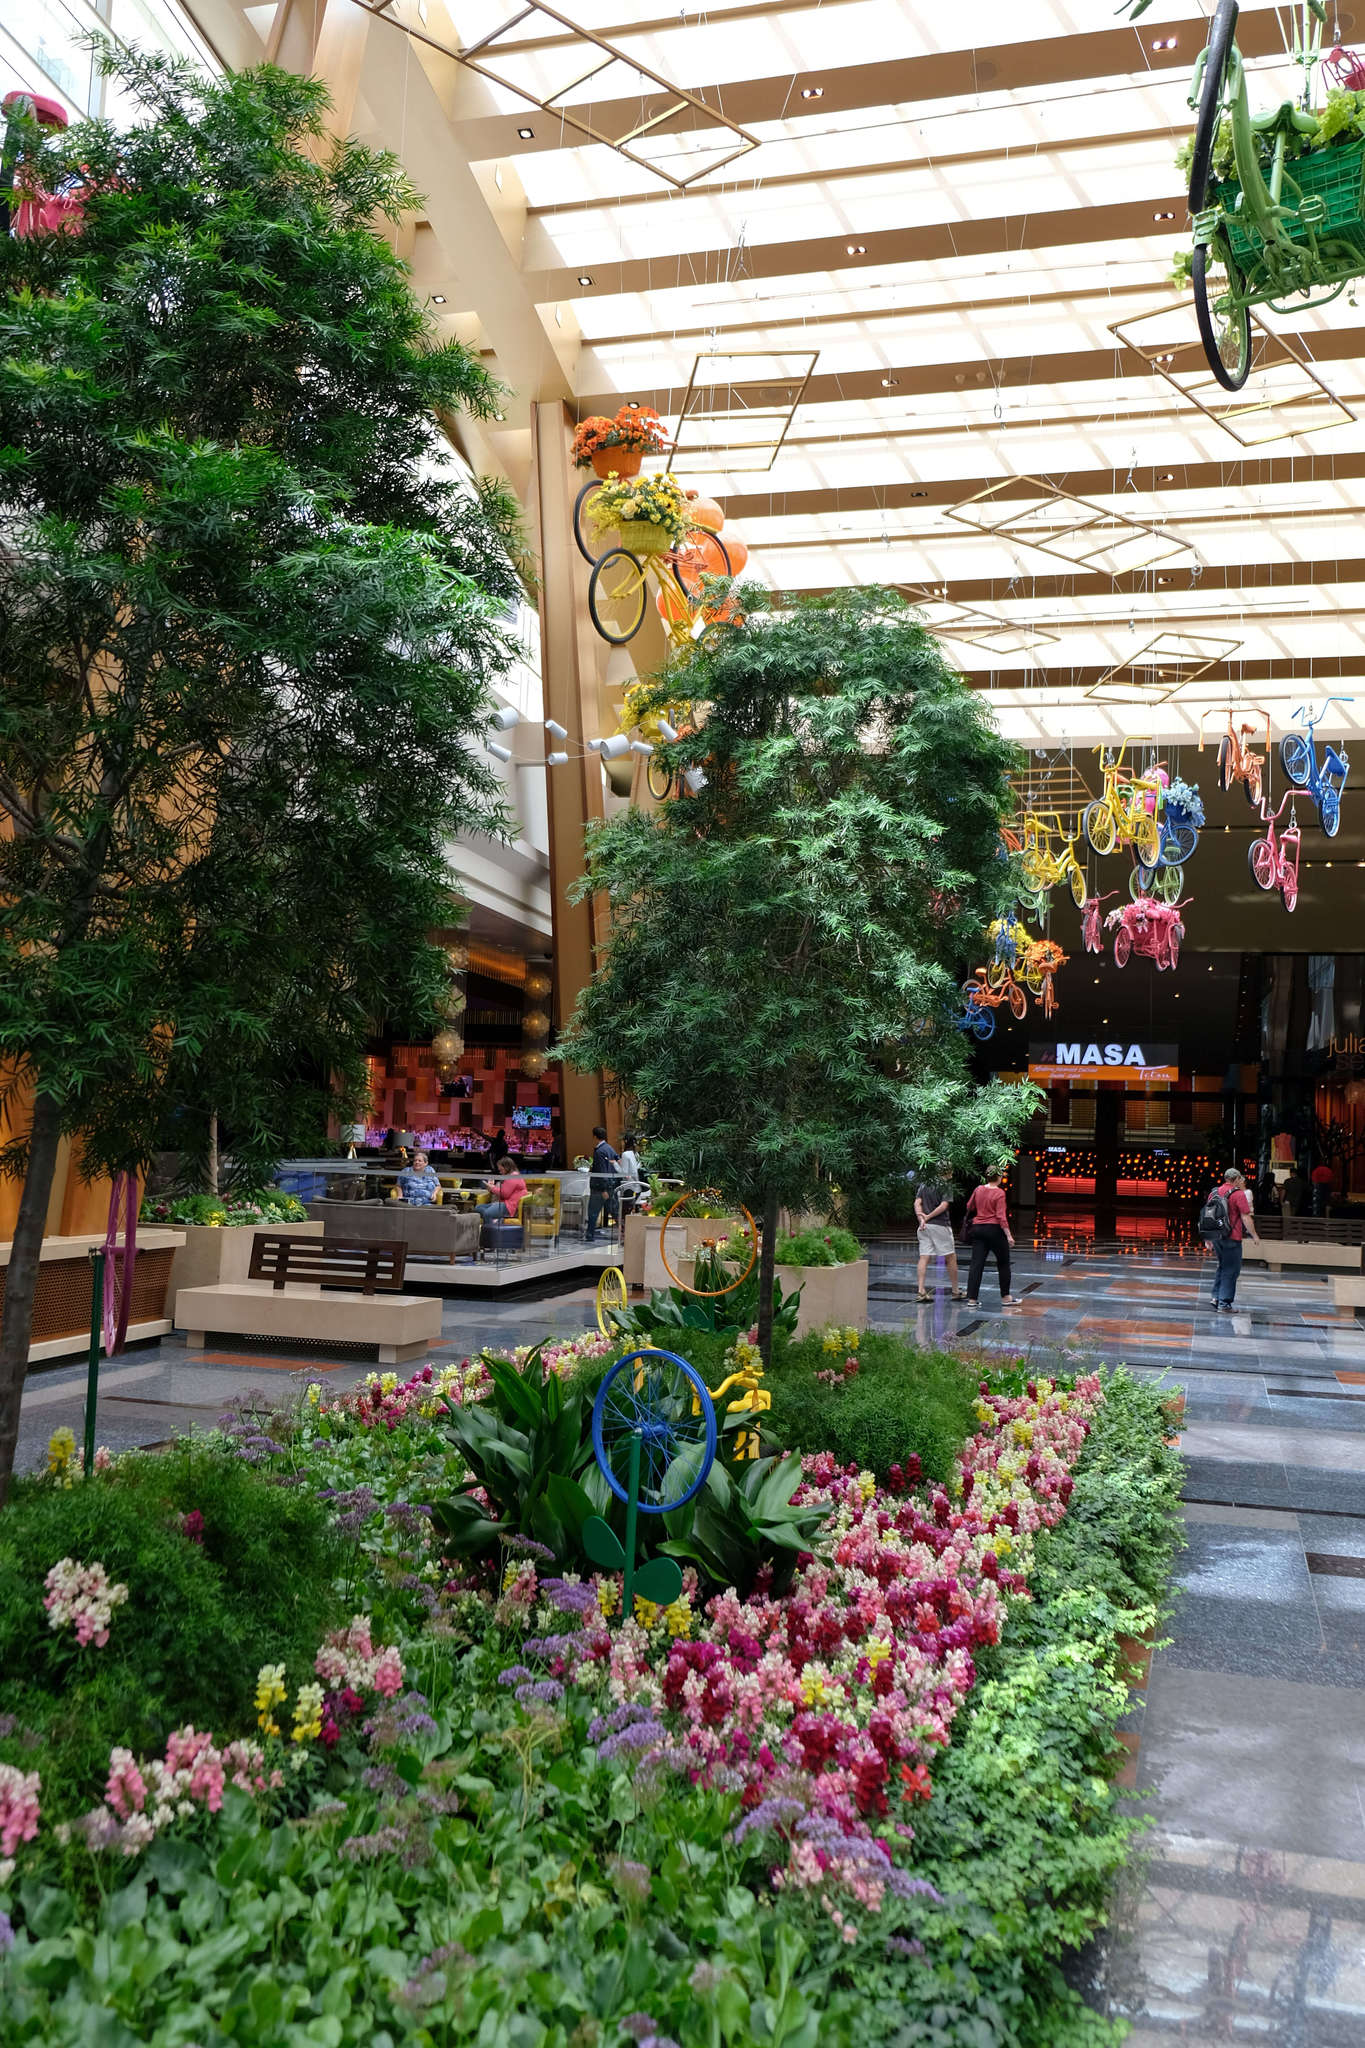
[{"xmin": 20, "ymin": 1231, "xmax": 1365, "ymax": 2048}]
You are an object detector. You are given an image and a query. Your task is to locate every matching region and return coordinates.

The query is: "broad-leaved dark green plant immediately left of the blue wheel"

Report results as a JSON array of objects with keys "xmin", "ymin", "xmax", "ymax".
[{"xmin": 432, "ymin": 1346, "xmax": 608, "ymax": 1565}]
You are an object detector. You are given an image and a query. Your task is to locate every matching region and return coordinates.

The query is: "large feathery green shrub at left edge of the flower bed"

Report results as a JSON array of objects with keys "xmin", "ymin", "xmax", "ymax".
[{"xmin": 0, "ymin": 1432, "xmax": 342, "ymax": 1810}]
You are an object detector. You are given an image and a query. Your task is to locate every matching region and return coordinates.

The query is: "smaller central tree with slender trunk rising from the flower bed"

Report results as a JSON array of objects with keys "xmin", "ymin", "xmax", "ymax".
[{"xmin": 561, "ymin": 588, "xmax": 1036, "ymax": 1356}]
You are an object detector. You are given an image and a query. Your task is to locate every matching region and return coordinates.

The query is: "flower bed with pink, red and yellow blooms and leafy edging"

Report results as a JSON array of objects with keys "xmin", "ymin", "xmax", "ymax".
[{"xmin": 0, "ymin": 1333, "xmax": 1179, "ymax": 2048}]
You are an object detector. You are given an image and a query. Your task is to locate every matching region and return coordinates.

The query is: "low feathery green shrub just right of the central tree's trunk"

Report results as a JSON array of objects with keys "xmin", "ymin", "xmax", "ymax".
[{"xmin": 763, "ymin": 1329, "xmax": 978, "ymax": 1481}]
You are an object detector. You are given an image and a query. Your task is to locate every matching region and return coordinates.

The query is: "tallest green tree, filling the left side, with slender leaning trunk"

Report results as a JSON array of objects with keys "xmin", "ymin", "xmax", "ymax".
[{"xmin": 0, "ymin": 53, "xmax": 518, "ymax": 1499}]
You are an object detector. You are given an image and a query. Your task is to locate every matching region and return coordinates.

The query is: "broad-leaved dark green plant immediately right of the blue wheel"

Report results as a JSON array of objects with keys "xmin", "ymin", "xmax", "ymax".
[{"xmin": 661, "ymin": 1458, "xmax": 825, "ymax": 1593}]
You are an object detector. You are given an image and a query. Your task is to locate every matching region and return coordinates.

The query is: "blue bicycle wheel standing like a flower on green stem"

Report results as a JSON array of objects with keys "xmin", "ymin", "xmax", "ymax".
[{"xmin": 591, "ymin": 1352, "xmax": 716, "ymax": 1516}]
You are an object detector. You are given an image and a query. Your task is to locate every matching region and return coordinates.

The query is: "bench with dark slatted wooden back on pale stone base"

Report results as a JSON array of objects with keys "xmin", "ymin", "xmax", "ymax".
[{"xmin": 176, "ymin": 1231, "xmax": 440, "ymax": 1366}]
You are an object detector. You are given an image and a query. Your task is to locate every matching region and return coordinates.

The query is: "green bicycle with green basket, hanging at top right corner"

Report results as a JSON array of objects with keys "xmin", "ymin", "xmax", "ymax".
[{"xmin": 1189, "ymin": 0, "xmax": 1365, "ymax": 391}]
